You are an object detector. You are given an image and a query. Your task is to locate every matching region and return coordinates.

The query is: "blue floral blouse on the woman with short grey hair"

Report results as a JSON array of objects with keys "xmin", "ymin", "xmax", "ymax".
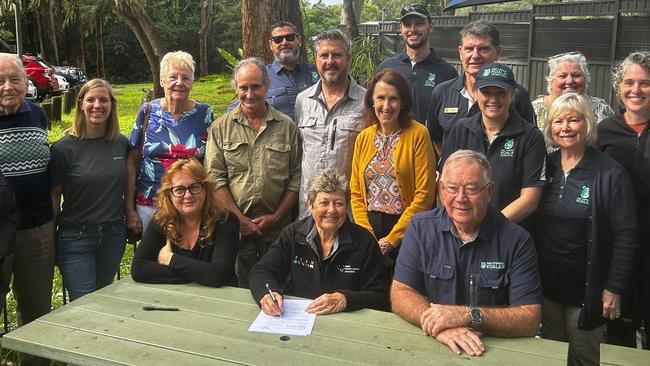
[{"xmin": 129, "ymin": 99, "xmax": 214, "ymax": 206}]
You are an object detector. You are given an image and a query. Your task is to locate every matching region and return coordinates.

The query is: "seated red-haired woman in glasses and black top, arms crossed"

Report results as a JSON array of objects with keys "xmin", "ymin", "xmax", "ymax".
[{"xmin": 131, "ymin": 159, "xmax": 239, "ymax": 287}]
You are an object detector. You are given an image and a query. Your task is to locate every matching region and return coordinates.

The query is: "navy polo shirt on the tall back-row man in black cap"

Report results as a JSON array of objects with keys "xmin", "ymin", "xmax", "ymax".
[{"xmin": 375, "ymin": 49, "xmax": 458, "ymax": 124}]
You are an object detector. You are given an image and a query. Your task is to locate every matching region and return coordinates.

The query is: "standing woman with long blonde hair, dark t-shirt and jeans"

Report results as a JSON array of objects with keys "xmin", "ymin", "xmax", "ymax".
[{"xmin": 48, "ymin": 79, "xmax": 128, "ymax": 300}]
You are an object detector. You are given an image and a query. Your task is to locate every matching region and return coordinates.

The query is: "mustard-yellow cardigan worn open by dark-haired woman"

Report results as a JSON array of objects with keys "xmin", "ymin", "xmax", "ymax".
[{"xmin": 350, "ymin": 121, "xmax": 436, "ymax": 246}]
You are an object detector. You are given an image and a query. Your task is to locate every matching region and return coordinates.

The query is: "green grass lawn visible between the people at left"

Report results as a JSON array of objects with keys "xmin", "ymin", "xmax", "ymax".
[{"xmin": 0, "ymin": 75, "xmax": 235, "ymax": 365}]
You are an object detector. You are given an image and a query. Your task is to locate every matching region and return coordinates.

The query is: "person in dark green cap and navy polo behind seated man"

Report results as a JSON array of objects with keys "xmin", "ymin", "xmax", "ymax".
[{"xmin": 438, "ymin": 63, "xmax": 546, "ymax": 228}]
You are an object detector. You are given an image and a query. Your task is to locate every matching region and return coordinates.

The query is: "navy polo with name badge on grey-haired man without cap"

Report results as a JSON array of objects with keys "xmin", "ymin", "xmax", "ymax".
[{"xmin": 426, "ymin": 75, "xmax": 536, "ymax": 142}]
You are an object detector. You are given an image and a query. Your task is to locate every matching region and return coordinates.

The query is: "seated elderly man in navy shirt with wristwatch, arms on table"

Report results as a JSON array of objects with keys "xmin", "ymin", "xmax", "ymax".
[{"xmin": 391, "ymin": 150, "xmax": 542, "ymax": 356}]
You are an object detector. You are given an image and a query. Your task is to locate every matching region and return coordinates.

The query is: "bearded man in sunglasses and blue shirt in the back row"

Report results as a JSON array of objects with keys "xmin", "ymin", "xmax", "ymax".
[{"xmin": 228, "ymin": 21, "xmax": 320, "ymax": 121}]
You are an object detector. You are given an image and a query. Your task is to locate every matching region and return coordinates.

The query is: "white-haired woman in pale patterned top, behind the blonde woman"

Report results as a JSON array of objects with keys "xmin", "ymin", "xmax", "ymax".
[{"xmin": 532, "ymin": 52, "xmax": 614, "ymax": 130}]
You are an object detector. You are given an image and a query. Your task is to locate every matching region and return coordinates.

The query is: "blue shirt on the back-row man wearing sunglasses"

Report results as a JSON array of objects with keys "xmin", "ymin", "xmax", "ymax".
[{"xmin": 228, "ymin": 61, "xmax": 320, "ymax": 121}]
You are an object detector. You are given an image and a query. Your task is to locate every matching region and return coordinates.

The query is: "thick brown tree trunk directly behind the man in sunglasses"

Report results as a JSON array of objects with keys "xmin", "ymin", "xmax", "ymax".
[{"xmin": 241, "ymin": 0, "xmax": 304, "ymax": 62}]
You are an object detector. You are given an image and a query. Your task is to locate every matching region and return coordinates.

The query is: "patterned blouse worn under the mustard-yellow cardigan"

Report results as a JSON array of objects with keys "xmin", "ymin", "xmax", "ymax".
[{"xmin": 365, "ymin": 130, "xmax": 404, "ymax": 215}]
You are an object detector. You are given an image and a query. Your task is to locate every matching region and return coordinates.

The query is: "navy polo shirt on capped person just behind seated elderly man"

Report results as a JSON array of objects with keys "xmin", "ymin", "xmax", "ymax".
[{"xmin": 438, "ymin": 109, "xmax": 546, "ymax": 210}]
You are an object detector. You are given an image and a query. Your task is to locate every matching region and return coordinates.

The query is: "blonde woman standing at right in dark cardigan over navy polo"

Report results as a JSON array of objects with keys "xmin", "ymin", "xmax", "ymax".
[{"xmin": 534, "ymin": 93, "xmax": 637, "ymax": 365}]
